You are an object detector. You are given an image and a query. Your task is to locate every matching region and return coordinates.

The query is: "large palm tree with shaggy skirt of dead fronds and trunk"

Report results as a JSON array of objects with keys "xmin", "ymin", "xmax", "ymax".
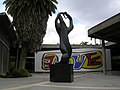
[{"xmin": 4, "ymin": 0, "xmax": 58, "ymax": 68}]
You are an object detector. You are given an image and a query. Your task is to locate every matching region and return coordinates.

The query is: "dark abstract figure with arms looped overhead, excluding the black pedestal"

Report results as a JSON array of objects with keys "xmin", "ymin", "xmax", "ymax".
[{"xmin": 55, "ymin": 12, "xmax": 73, "ymax": 64}]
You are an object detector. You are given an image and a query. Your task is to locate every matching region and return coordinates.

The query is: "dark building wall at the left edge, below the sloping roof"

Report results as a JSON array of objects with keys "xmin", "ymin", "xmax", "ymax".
[{"xmin": 0, "ymin": 27, "xmax": 9, "ymax": 75}]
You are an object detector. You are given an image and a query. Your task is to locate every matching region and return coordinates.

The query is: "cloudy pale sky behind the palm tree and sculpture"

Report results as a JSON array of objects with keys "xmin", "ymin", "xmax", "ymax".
[{"xmin": 0, "ymin": 0, "xmax": 120, "ymax": 44}]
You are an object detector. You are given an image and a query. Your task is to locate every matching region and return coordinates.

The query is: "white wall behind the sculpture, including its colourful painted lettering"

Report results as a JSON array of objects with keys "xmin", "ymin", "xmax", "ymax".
[{"xmin": 35, "ymin": 48, "xmax": 111, "ymax": 72}]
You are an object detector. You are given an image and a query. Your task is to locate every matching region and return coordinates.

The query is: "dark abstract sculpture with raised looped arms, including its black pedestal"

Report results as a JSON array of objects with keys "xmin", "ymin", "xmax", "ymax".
[{"xmin": 50, "ymin": 12, "xmax": 74, "ymax": 82}]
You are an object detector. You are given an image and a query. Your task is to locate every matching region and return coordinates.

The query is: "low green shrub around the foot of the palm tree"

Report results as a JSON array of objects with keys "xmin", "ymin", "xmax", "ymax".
[{"xmin": 10, "ymin": 69, "xmax": 32, "ymax": 77}]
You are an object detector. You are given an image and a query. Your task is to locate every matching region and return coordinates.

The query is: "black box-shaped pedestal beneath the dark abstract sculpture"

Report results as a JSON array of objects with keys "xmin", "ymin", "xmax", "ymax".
[{"xmin": 50, "ymin": 64, "xmax": 73, "ymax": 82}]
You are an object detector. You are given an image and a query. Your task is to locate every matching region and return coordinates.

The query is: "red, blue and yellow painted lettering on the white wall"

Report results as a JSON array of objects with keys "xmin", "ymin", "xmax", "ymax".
[{"xmin": 42, "ymin": 51, "xmax": 103, "ymax": 70}]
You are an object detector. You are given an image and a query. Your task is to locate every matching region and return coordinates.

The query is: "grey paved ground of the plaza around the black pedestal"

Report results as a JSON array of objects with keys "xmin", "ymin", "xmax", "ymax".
[{"xmin": 0, "ymin": 71, "xmax": 120, "ymax": 90}]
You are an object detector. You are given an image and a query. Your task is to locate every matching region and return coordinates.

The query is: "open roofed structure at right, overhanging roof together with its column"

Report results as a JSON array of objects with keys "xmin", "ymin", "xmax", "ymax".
[{"xmin": 88, "ymin": 13, "xmax": 120, "ymax": 74}]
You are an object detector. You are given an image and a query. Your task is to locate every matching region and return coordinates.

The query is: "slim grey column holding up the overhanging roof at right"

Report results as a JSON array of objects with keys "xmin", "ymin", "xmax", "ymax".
[{"xmin": 102, "ymin": 40, "xmax": 107, "ymax": 75}]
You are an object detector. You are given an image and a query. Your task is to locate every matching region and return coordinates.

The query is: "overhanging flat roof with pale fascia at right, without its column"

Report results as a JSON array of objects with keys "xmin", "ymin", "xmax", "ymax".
[{"xmin": 88, "ymin": 13, "xmax": 120, "ymax": 43}]
